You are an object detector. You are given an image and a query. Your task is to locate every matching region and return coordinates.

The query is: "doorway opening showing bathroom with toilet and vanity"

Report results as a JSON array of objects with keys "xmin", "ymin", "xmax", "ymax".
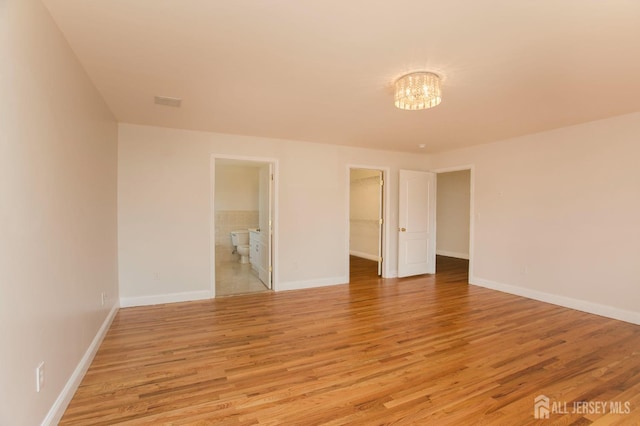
[{"xmin": 213, "ymin": 158, "xmax": 275, "ymax": 297}]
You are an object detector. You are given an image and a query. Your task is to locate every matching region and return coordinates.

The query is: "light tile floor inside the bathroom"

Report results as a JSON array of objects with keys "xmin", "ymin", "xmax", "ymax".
[{"xmin": 216, "ymin": 246, "xmax": 269, "ymax": 297}]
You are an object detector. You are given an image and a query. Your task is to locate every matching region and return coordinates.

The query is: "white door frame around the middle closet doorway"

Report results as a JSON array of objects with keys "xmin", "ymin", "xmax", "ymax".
[{"xmin": 344, "ymin": 164, "xmax": 392, "ymax": 279}]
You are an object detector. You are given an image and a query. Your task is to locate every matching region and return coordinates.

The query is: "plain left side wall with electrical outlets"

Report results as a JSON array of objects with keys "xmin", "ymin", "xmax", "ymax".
[{"xmin": 0, "ymin": 0, "xmax": 118, "ymax": 425}]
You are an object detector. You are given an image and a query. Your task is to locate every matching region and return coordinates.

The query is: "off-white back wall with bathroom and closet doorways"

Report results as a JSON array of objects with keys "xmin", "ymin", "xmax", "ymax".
[{"xmin": 118, "ymin": 124, "xmax": 426, "ymax": 304}]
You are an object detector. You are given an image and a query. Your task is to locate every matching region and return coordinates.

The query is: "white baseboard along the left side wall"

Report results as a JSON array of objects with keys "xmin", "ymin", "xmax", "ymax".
[{"xmin": 42, "ymin": 302, "xmax": 119, "ymax": 426}]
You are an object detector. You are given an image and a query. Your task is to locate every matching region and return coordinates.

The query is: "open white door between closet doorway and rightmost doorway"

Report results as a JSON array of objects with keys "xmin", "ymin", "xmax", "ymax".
[{"xmin": 398, "ymin": 170, "xmax": 436, "ymax": 277}]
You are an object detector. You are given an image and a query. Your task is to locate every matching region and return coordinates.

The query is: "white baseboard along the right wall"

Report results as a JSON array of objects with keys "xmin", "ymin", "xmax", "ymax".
[{"xmin": 469, "ymin": 277, "xmax": 640, "ymax": 325}]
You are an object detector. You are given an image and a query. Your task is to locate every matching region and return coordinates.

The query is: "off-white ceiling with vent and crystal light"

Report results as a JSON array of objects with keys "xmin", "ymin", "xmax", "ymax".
[{"xmin": 43, "ymin": 0, "xmax": 640, "ymax": 152}]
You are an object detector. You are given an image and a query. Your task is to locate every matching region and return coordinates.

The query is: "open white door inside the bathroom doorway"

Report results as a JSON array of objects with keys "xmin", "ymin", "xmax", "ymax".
[{"xmin": 258, "ymin": 163, "xmax": 273, "ymax": 289}]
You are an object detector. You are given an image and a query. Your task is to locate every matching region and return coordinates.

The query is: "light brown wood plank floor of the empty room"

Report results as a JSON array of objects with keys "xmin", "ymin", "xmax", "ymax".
[{"xmin": 61, "ymin": 258, "xmax": 640, "ymax": 425}]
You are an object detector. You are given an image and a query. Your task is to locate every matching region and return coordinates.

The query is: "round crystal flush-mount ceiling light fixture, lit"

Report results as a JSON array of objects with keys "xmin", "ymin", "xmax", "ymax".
[{"xmin": 395, "ymin": 71, "xmax": 442, "ymax": 110}]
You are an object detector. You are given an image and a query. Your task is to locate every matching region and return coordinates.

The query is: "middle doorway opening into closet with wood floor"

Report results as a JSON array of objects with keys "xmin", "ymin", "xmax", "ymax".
[{"xmin": 349, "ymin": 167, "xmax": 384, "ymax": 282}]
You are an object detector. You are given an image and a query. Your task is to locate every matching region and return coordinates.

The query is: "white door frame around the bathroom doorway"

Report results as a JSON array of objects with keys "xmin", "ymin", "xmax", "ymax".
[{"xmin": 209, "ymin": 154, "xmax": 280, "ymax": 299}]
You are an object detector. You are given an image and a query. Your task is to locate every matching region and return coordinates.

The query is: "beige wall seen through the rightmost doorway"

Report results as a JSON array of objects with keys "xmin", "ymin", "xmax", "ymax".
[{"xmin": 436, "ymin": 170, "xmax": 471, "ymax": 259}]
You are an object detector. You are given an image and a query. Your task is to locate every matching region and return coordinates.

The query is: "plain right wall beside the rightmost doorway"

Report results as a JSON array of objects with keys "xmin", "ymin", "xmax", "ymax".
[{"xmin": 432, "ymin": 113, "xmax": 640, "ymax": 323}]
